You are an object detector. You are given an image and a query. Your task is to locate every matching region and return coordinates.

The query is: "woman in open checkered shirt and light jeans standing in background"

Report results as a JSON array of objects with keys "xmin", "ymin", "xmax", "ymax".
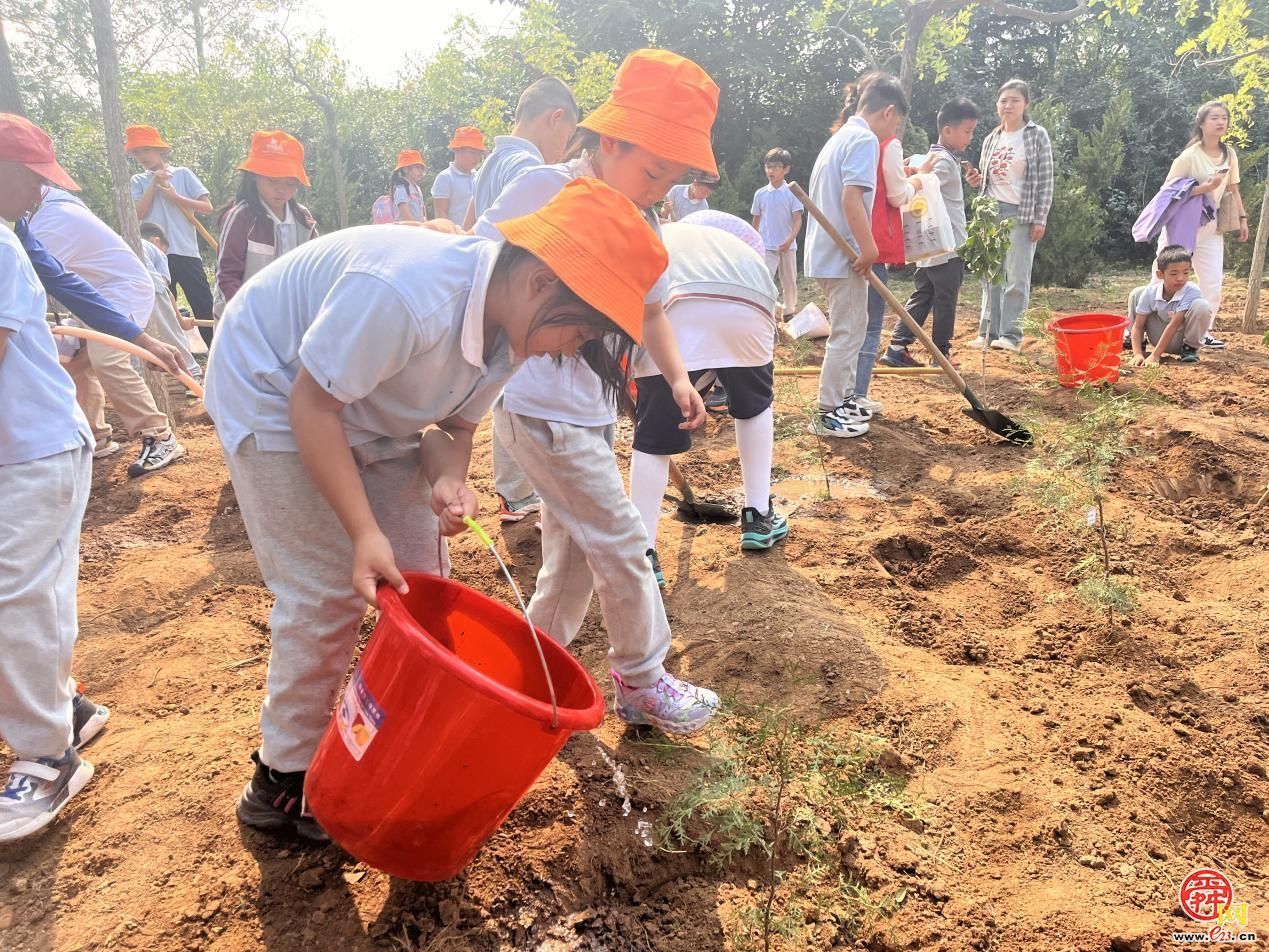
[{"xmin": 970, "ymin": 80, "xmax": 1053, "ymax": 352}]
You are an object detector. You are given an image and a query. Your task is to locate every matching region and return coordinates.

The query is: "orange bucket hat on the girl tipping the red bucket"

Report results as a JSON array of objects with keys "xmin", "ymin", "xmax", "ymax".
[{"xmin": 497, "ymin": 178, "xmax": 670, "ymax": 344}]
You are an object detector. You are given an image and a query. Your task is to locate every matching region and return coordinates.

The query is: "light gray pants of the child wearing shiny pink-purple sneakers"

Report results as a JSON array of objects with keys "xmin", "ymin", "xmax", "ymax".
[{"xmin": 494, "ymin": 404, "xmax": 670, "ymax": 687}]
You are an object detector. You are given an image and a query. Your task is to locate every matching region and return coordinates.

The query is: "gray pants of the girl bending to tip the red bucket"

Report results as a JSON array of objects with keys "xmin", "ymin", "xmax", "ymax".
[{"xmin": 225, "ymin": 437, "xmax": 448, "ymax": 772}]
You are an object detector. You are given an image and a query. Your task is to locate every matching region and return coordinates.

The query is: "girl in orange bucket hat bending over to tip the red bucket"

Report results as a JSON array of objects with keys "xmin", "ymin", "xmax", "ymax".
[{"xmin": 206, "ymin": 179, "xmax": 666, "ymax": 840}]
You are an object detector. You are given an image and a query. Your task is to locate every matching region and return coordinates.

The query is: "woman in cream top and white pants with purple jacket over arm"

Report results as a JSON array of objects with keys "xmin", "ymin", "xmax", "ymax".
[{"xmin": 1160, "ymin": 99, "xmax": 1247, "ymax": 349}]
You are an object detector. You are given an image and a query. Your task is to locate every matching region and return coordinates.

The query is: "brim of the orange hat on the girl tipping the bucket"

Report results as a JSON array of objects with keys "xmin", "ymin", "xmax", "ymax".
[{"xmin": 496, "ymin": 213, "xmax": 646, "ymax": 344}]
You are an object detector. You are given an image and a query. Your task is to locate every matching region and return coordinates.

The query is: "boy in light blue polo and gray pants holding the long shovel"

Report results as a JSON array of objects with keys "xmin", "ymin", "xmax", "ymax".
[{"xmin": 805, "ymin": 74, "xmax": 907, "ymax": 438}]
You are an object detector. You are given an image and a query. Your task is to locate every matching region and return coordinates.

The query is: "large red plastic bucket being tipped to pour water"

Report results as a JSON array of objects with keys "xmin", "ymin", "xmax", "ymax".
[{"xmin": 305, "ymin": 572, "xmax": 604, "ymax": 882}]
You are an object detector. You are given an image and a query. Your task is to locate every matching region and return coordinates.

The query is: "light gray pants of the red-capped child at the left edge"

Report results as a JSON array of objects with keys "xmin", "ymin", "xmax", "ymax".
[{"xmin": 0, "ymin": 446, "xmax": 93, "ymax": 760}]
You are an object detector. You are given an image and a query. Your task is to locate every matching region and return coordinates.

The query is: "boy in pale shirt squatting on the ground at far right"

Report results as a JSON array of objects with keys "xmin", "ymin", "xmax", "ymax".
[{"xmin": 1128, "ymin": 245, "xmax": 1212, "ymax": 367}]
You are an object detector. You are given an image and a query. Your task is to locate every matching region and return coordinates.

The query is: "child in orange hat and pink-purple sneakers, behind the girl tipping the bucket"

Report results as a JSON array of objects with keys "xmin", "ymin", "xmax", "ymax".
[{"xmin": 476, "ymin": 50, "xmax": 718, "ymax": 734}]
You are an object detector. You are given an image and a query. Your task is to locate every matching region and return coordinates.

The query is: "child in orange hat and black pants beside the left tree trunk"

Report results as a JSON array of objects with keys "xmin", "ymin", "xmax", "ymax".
[{"xmin": 123, "ymin": 126, "xmax": 212, "ymax": 344}]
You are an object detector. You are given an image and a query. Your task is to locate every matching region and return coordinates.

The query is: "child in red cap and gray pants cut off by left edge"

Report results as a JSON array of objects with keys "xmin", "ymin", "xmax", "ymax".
[{"xmin": 0, "ymin": 114, "xmax": 109, "ymax": 842}]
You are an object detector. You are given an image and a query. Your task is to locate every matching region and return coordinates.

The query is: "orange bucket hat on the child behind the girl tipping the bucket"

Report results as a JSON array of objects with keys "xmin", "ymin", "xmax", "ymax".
[{"xmin": 580, "ymin": 50, "xmax": 718, "ymax": 175}]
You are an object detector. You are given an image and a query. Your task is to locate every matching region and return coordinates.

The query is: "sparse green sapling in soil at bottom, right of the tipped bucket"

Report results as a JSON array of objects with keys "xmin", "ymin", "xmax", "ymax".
[{"xmin": 659, "ymin": 704, "xmax": 916, "ymax": 948}]
